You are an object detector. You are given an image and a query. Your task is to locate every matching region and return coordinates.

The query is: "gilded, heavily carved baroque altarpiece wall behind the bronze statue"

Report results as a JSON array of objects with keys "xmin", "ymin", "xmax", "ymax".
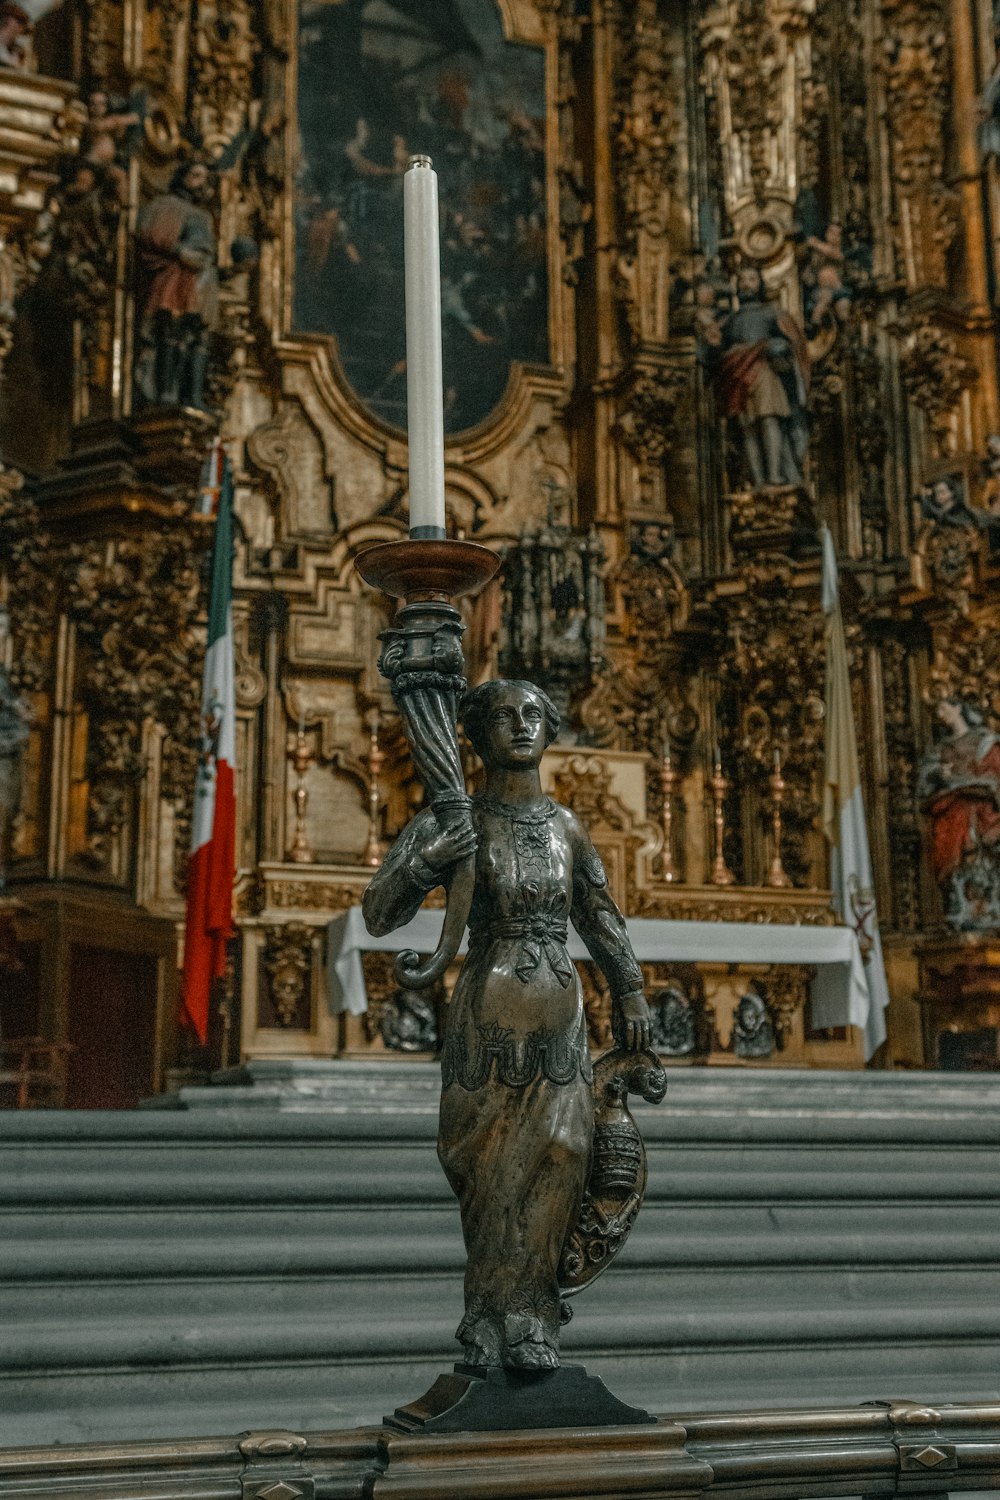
[{"xmin": 0, "ymin": 0, "xmax": 1000, "ymax": 1092}]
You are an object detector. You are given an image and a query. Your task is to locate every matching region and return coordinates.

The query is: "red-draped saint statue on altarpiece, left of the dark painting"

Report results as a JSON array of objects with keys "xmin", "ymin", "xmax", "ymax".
[{"xmin": 135, "ymin": 161, "xmax": 219, "ymax": 410}]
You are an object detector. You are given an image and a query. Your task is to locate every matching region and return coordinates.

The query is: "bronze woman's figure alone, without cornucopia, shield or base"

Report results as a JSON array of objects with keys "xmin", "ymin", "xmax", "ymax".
[{"xmin": 364, "ymin": 681, "xmax": 653, "ymax": 1371}]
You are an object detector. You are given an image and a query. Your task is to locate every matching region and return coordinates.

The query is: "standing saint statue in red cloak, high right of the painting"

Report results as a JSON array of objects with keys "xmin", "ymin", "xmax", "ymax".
[{"xmin": 702, "ymin": 266, "xmax": 810, "ymax": 489}]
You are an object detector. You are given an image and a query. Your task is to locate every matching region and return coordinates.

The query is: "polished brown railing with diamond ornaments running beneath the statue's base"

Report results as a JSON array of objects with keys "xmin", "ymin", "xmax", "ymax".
[{"xmin": 0, "ymin": 1401, "xmax": 1000, "ymax": 1500}]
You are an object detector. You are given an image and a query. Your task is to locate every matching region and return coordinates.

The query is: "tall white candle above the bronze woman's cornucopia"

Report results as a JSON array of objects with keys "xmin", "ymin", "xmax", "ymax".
[{"xmin": 403, "ymin": 156, "xmax": 445, "ymax": 537}]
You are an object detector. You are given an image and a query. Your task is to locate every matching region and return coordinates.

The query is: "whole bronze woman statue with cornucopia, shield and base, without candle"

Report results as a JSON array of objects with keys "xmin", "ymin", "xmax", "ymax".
[{"xmin": 357, "ymin": 540, "xmax": 666, "ymax": 1431}]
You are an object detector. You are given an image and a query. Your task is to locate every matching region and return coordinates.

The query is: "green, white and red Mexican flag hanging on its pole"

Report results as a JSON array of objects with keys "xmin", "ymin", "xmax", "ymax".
[{"xmin": 183, "ymin": 455, "xmax": 235, "ymax": 1046}]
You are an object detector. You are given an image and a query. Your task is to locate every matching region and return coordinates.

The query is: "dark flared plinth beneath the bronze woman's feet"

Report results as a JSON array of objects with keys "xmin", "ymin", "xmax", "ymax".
[{"xmin": 385, "ymin": 1365, "xmax": 657, "ymax": 1433}]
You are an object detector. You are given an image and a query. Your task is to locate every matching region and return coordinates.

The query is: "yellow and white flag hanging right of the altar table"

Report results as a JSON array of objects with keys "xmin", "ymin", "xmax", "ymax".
[{"xmin": 813, "ymin": 527, "xmax": 889, "ymax": 1058}]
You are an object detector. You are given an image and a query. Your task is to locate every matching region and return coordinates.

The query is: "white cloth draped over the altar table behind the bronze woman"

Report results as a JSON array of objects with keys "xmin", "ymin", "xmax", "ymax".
[{"xmin": 327, "ymin": 906, "xmax": 870, "ymax": 1028}]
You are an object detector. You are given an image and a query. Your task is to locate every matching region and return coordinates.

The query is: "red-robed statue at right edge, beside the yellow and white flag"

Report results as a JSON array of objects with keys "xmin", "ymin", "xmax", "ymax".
[{"xmin": 919, "ymin": 698, "xmax": 1000, "ymax": 932}]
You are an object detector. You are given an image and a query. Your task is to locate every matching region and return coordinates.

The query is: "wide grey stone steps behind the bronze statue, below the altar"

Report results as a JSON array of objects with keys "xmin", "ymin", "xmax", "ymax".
[{"xmin": 0, "ymin": 1062, "xmax": 1000, "ymax": 1448}]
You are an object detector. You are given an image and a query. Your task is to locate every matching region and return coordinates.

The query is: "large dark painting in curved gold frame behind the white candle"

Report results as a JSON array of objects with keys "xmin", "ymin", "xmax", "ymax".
[{"xmin": 295, "ymin": 0, "xmax": 549, "ymax": 432}]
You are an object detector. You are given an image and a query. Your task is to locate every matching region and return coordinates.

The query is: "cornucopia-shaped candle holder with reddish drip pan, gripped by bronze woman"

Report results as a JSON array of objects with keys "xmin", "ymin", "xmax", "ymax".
[{"xmin": 354, "ymin": 537, "xmax": 499, "ymax": 990}]
